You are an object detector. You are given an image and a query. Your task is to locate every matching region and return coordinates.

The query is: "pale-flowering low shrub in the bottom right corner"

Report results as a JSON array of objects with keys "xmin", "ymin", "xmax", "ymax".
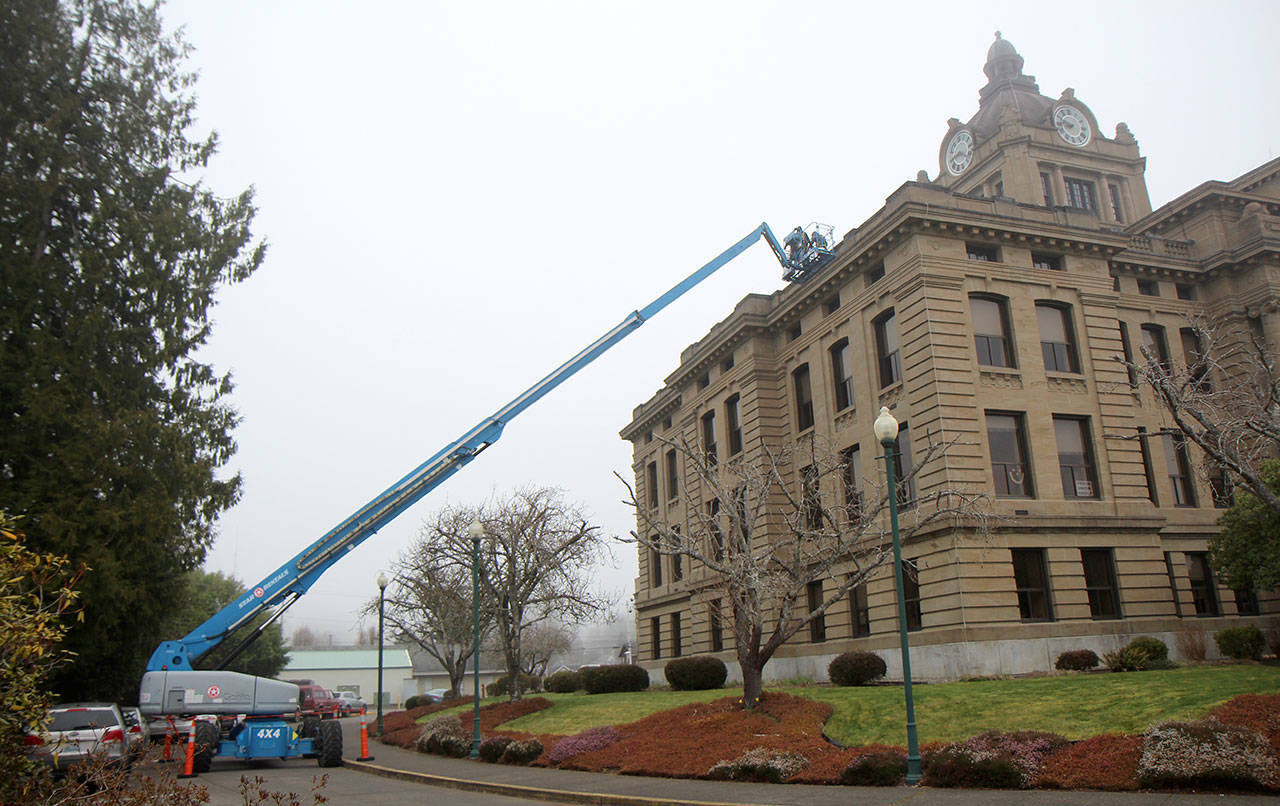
[{"xmin": 1138, "ymin": 719, "xmax": 1276, "ymax": 788}]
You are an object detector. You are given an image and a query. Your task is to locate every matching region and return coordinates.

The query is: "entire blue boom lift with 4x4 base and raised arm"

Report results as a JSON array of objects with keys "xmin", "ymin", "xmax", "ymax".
[{"xmin": 138, "ymin": 224, "xmax": 832, "ymax": 773}]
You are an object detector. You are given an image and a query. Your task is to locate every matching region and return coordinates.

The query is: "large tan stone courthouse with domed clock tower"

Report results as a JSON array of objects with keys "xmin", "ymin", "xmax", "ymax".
[{"xmin": 622, "ymin": 35, "xmax": 1280, "ymax": 679}]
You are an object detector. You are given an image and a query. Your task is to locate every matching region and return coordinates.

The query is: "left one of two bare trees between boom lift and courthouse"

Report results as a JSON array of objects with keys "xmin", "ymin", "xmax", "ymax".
[{"xmin": 364, "ymin": 508, "xmax": 493, "ymax": 696}]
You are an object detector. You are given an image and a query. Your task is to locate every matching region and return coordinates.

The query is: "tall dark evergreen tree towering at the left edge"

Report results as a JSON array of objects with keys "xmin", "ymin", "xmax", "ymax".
[{"xmin": 0, "ymin": 0, "xmax": 265, "ymax": 700}]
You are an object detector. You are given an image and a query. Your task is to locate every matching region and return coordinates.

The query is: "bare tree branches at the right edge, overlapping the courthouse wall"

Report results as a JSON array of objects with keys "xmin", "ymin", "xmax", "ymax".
[{"xmin": 1116, "ymin": 315, "xmax": 1280, "ymax": 514}]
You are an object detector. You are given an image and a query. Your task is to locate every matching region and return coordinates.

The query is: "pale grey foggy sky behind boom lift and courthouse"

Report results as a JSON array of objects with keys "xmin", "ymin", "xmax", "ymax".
[{"xmin": 164, "ymin": 0, "xmax": 1280, "ymax": 641}]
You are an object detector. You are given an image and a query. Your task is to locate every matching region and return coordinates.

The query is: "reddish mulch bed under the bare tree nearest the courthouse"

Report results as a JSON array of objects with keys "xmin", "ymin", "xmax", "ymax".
[{"xmin": 547, "ymin": 692, "xmax": 844, "ymax": 778}]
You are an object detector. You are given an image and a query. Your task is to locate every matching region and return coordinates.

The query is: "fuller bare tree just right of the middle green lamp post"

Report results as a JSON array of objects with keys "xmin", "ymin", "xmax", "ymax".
[{"xmin": 434, "ymin": 487, "xmax": 609, "ymax": 700}]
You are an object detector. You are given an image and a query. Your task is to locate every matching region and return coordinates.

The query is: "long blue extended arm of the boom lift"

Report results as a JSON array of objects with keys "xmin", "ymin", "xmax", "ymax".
[{"xmin": 147, "ymin": 224, "xmax": 831, "ymax": 672}]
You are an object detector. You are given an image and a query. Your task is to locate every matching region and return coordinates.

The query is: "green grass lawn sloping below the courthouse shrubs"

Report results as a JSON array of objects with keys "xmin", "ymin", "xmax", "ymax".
[{"xmin": 478, "ymin": 664, "xmax": 1280, "ymax": 745}]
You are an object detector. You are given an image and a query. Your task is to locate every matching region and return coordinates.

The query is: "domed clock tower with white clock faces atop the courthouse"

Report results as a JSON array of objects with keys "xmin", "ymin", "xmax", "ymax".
[{"xmin": 934, "ymin": 31, "xmax": 1151, "ymax": 228}]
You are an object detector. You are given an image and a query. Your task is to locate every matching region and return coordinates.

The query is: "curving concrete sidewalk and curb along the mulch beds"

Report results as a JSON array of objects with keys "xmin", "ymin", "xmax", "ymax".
[{"xmin": 343, "ymin": 716, "xmax": 1260, "ymax": 806}]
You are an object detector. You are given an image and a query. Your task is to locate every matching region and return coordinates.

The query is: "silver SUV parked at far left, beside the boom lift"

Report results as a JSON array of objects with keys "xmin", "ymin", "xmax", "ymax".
[{"xmin": 23, "ymin": 702, "xmax": 129, "ymax": 773}]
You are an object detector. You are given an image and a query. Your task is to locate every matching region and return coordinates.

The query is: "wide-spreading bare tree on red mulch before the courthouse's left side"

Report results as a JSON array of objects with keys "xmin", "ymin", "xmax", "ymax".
[{"xmin": 620, "ymin": 439, "xmax": 987, "ymax": 709}]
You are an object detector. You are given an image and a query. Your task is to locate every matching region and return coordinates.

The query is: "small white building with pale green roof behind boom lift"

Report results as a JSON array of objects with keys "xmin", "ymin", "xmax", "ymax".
[{"xmin": 280, "ymin": 646, "xmax": 413, "ymax": 707}]
